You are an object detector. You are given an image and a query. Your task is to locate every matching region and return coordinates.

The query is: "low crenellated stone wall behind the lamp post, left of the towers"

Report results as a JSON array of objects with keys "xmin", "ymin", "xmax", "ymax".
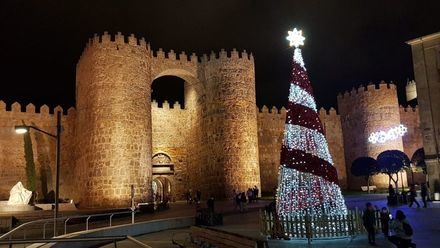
[{"xmin": 0, "ymin": 101, "xmax": 75, "ymax": 200}]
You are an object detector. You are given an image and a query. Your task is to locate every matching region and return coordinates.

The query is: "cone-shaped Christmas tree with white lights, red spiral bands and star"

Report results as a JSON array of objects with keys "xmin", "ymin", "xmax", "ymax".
[{"xmin": 277, "ymin": 28, "xmax": 347, "ymax": 216}]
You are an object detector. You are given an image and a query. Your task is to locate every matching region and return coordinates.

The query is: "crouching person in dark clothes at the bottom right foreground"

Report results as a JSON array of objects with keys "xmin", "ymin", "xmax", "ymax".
[{"xmin": 388, "ymin": 210, "xmax": 415, "ymax": 248}]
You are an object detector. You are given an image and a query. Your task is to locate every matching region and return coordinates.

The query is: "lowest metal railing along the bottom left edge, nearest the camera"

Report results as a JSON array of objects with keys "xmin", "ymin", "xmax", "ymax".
[{"xmin": 0, "ymin": 236, "xmax": 152, "ymax": 248}]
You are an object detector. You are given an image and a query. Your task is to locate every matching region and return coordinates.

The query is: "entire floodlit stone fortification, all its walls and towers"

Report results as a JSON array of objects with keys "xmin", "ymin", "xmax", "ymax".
[{"xmin": 0, "ymin": 33, "xmax": 421, "ymax": 208}]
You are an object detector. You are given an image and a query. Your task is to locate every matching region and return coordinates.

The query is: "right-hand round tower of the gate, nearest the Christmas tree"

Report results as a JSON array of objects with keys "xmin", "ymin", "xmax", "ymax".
[{"xmin": 201, "ymin": 50, "xmax": 261, "ymax": 197}]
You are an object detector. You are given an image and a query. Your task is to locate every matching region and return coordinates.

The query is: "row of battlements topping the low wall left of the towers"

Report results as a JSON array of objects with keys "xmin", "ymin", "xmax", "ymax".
[{"xmin": 0, "ymin": 100, "xmax": 75, "ymax": 116}]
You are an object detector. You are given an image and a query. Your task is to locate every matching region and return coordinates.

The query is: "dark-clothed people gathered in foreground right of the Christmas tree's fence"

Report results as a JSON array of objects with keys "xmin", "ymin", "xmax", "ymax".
[{"xmin": 362, "ymin": 202, "xmax": 415, "ymax": 248}]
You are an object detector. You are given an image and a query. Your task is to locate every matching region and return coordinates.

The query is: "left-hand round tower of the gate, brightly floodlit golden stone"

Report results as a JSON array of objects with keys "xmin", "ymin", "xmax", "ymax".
[{"xmin": 75, "ymin": 33, "xmax": 152, "ymax": 207}]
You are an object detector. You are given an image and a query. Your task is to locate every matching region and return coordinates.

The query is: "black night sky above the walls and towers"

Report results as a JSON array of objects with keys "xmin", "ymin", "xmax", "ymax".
[{"xmin": 0, "ymin": 0, "xmax": 440, "ymax": 107}]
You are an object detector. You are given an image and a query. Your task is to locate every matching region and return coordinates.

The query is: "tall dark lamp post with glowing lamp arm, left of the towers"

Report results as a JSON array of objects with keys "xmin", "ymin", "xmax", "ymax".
[{"xmin": 15, "ymin": 111, "xmax": 61, "ymax": 237}]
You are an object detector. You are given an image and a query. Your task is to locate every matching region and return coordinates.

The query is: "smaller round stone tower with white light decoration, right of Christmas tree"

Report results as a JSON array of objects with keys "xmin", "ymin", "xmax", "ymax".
[{"xmin": 338, "ymin": 82, "xmax": 406, "ymax": 190}]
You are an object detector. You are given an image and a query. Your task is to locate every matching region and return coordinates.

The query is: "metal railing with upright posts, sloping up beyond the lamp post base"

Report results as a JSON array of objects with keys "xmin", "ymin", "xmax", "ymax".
[{"xmin": 0, "ymin": 210, "xmax": 136, "ymax": 241}]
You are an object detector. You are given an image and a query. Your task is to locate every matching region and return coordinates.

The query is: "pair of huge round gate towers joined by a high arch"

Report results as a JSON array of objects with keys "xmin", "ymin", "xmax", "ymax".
[{"xmin": 75, "ymin": 33, "xmax": 260, "ymax": 207}]
